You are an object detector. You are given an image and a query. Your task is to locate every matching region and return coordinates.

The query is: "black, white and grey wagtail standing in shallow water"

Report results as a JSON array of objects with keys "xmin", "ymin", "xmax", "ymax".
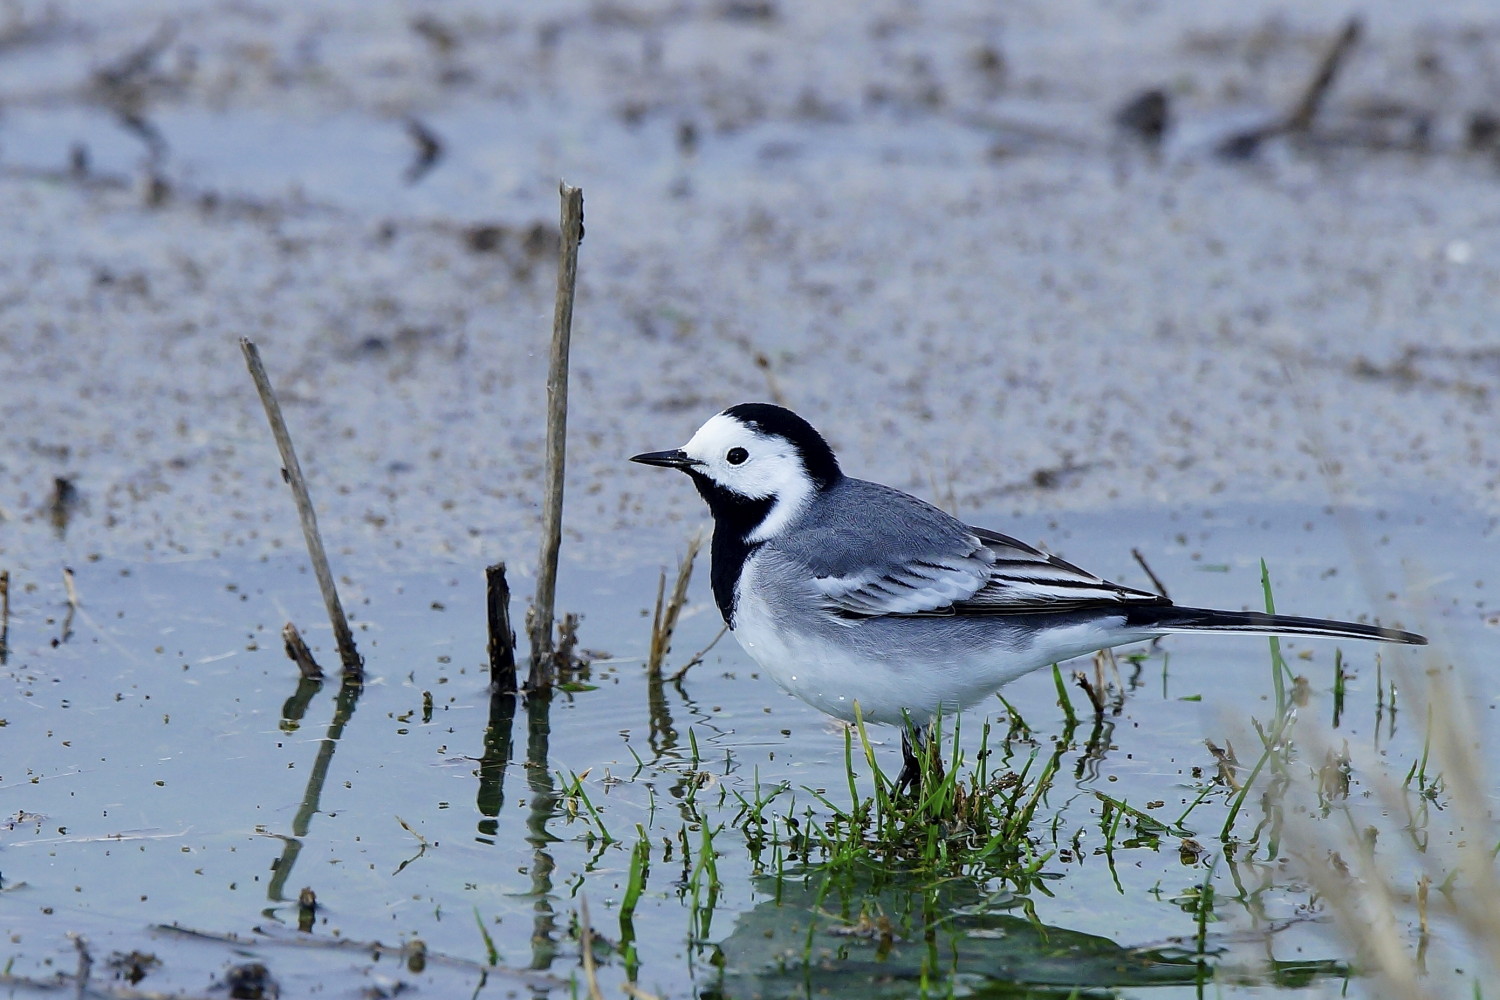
[{"xmin": 630, "ymin": 402, "xmax": 1427, "ymax": 787}]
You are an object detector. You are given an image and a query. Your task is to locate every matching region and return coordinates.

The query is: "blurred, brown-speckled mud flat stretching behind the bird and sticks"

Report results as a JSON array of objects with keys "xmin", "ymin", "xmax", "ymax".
[{"xmin": 0, "ymin": 0, "xmax": 1500, "ymax": 578}]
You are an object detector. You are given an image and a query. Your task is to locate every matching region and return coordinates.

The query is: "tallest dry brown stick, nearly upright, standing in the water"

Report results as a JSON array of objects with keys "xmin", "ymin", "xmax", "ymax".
[{"xmin": 527, "ymin": 181, "xmax": 584, "ymax": 691}]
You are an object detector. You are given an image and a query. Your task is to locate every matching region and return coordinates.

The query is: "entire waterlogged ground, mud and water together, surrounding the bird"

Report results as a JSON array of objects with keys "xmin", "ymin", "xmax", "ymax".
[{"xmin": 0, "ymin": 0, "xmax": 1500, "ymax": 999}]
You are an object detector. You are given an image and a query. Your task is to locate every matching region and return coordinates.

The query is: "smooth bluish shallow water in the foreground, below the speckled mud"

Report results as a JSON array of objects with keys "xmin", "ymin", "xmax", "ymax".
[{"xmin": 0, "ymin": 502, "xmax": 1497, "ymax": 996}]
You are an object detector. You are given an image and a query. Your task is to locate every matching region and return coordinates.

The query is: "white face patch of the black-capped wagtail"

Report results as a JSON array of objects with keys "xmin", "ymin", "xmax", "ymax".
[{"xmin": 683, "ymin": 414, "xmax": 813, "ymax": 543}]
